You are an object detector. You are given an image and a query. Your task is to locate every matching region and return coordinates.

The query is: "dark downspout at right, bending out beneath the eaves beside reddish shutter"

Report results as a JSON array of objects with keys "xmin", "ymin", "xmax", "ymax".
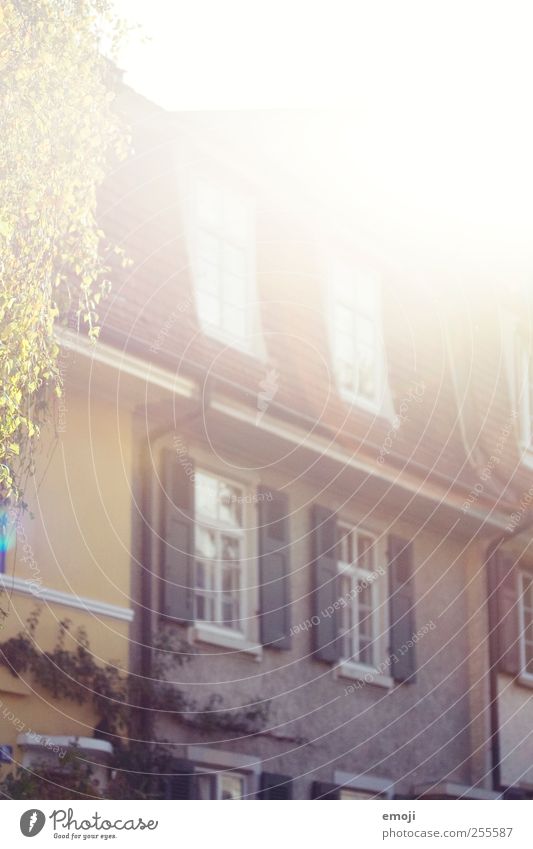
[{"xmin": 485, "ymin": 510, "xmax": 533, "ymax": 793}]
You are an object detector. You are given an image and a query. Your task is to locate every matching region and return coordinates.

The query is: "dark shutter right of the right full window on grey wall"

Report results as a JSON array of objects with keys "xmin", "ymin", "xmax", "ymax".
[{"xmin": 389, "ymin": 536, "xmax": 416, "ymax": 683}]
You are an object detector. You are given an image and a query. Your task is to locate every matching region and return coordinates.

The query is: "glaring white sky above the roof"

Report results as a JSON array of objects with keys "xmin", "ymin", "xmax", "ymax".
[{"xmin": 118, "ymin": 0, "xmax": 533, "ymax": 280}]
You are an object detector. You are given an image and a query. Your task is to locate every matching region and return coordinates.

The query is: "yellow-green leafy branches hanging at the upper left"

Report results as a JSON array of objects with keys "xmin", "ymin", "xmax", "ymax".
[{"xmin": 0, "ymin": 0, "xmax": 127, "ymax": 504}]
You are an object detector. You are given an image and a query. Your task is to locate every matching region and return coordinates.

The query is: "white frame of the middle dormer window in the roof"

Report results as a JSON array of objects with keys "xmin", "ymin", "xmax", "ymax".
[{"xmin": 326, "ymin": 256, "xmax": 386, "ymax": 417}]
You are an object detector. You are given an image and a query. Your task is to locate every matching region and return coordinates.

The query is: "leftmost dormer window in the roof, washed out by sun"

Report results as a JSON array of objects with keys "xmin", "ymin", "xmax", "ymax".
[{"xmin": 192, "ymin": 179, "xmax": 255, "ymax": 347}]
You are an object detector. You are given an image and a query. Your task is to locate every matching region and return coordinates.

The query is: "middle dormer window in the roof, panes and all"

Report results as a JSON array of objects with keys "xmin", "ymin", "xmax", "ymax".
[{"xmin": 330, "ymin": 263, "xmax": 383, "ymax": 407}]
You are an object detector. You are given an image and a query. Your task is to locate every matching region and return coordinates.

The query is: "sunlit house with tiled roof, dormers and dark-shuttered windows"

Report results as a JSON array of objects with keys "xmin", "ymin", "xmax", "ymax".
[{"xmin": 0, "ymin": 83, "xmax": 533, "ymax": 800}]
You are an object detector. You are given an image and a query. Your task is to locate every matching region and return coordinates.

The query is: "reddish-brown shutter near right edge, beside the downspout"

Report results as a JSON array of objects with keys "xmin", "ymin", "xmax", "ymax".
[{"xmin": 488, "ymin": 549, "xmax": 520, "ymax": 675}]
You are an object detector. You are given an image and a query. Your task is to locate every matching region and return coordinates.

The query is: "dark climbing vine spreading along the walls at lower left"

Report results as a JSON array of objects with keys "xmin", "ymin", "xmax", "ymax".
[{"xmin": 0, "ymin": 609, "xmax": 271, "ymax": 799}]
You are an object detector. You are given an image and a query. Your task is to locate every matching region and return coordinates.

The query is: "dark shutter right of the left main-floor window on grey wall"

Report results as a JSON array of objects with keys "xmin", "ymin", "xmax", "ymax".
[{"xmin": 258, "ymin": 487, "xmax": 291, "ymax": 649}]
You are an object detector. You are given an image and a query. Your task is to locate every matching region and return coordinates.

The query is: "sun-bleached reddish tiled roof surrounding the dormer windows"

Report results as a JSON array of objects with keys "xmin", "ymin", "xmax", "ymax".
[{"xmin": 94, "ymin": 91, "xmax": 529, "ymax": 520}]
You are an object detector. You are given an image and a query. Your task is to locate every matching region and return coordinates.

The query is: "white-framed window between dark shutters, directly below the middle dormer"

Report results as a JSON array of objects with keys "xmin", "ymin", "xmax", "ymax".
[{"xmin": 338, "ymin": 524, "xmax": 380, "ymax": 666}]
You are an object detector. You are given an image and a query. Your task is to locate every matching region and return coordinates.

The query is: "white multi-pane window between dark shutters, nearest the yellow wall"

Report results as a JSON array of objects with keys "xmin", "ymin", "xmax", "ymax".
[{"xmin": 194, "ymin": 470, "xmax": 245, "ymax": 631}]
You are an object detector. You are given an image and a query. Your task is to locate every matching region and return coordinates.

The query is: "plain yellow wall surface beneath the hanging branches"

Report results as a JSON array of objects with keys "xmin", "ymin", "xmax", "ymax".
[{"xmin": 0, "ymin": 362, "xmax": 132, "ymax": 772}]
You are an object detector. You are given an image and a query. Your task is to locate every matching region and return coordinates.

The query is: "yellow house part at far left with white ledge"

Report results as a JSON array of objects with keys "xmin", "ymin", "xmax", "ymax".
[{"xmin": 0, "ymin": 334, "xmax": 133, "ymax": 784}]
